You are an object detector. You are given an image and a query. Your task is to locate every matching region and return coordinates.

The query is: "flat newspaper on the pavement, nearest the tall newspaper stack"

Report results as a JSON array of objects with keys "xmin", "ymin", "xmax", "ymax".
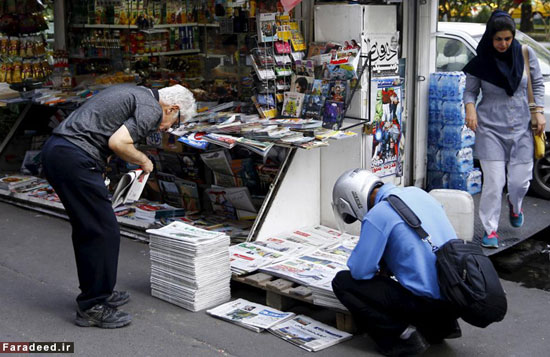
[{"xmin": 206, "ymin": 299, "xmax": 295, "ymax": 332}]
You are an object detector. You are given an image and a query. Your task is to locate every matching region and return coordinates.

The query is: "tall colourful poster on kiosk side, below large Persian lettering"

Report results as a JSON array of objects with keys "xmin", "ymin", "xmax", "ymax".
[{"xmin": 370, "ymin": 77, "xmax": 404, "ymax": 177}]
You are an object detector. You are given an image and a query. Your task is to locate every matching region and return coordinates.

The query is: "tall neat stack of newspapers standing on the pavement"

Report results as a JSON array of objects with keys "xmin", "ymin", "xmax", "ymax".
[{"xmin": 147, "ymin": 222, "xmax": 231, "ymax": 311}]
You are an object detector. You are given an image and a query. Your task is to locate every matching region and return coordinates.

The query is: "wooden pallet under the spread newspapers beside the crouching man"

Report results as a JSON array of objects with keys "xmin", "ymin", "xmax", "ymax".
[{"xmin": 232, "ymin": 273, "xmax": 357, "ymax": 333}]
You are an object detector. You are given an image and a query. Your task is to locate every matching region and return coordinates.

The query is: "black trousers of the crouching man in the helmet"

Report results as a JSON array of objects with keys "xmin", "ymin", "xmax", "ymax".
[{"xmin": 332, "ymin": 271, "xmax": 457, "ymax": 348}]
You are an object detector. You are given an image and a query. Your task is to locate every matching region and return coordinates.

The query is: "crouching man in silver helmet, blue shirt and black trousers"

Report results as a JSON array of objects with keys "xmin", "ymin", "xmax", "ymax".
[{"xmin": 332, "ymin": 169, "xmax": 462, "ymax": 356}]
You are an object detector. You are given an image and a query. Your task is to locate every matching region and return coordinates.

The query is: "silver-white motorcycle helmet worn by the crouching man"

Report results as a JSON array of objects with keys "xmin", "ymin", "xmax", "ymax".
[{"xmin": 332, "ymin": 169, "xmax": 384, "ymax": 231}]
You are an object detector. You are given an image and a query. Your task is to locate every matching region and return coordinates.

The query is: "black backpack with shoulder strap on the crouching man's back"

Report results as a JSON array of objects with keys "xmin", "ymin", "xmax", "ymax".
[{"xmin": 386, "ymin": 195, "xmax": 507, "ymax": 327}]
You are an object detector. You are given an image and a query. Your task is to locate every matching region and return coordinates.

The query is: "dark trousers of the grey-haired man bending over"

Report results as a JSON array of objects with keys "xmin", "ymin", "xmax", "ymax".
[{"xmin": 41, "ymin": 135, "xmax": 120, "ymax": 310}]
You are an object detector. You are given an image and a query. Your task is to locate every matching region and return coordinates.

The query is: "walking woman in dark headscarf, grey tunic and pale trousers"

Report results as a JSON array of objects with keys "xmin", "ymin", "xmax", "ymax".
[{"xmin": 464, "ymin": 10, "xmax": 546, "ymax": 248}]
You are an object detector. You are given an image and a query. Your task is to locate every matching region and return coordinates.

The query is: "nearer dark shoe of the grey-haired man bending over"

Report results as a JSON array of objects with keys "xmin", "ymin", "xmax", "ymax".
[{"xmin": 75, "ymin": 304, "xmax": 132, "ymax": 328}]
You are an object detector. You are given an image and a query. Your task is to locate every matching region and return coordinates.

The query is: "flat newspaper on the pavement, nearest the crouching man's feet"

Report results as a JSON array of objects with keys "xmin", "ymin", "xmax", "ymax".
[{"xmin": 268, "ymin": 315, "xmax": 352, "ymax": 352}]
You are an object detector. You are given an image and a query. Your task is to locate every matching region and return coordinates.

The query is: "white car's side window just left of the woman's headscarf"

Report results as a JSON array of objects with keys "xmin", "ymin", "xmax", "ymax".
[{"xmin": 435, "ymin": 36, "xmax": 475, "ymax": 72}]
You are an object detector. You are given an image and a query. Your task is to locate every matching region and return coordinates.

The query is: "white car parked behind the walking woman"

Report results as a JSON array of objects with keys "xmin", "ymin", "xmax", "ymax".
[{"xmin": 436, "ymin": 22, "xmax": 550, "ymax": 199}]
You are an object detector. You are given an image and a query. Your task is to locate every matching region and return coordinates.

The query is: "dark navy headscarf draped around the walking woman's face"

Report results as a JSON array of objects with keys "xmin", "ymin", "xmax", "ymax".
[{"xmin": 463, "ymin": 10, "xmax": 524, "ymax": 96}]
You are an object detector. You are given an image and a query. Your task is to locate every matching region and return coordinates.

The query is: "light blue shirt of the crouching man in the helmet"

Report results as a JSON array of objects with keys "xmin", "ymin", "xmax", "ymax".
[{"xmin": 348, "ymin": 183, "xmax": 456, "ymax": 299}]
